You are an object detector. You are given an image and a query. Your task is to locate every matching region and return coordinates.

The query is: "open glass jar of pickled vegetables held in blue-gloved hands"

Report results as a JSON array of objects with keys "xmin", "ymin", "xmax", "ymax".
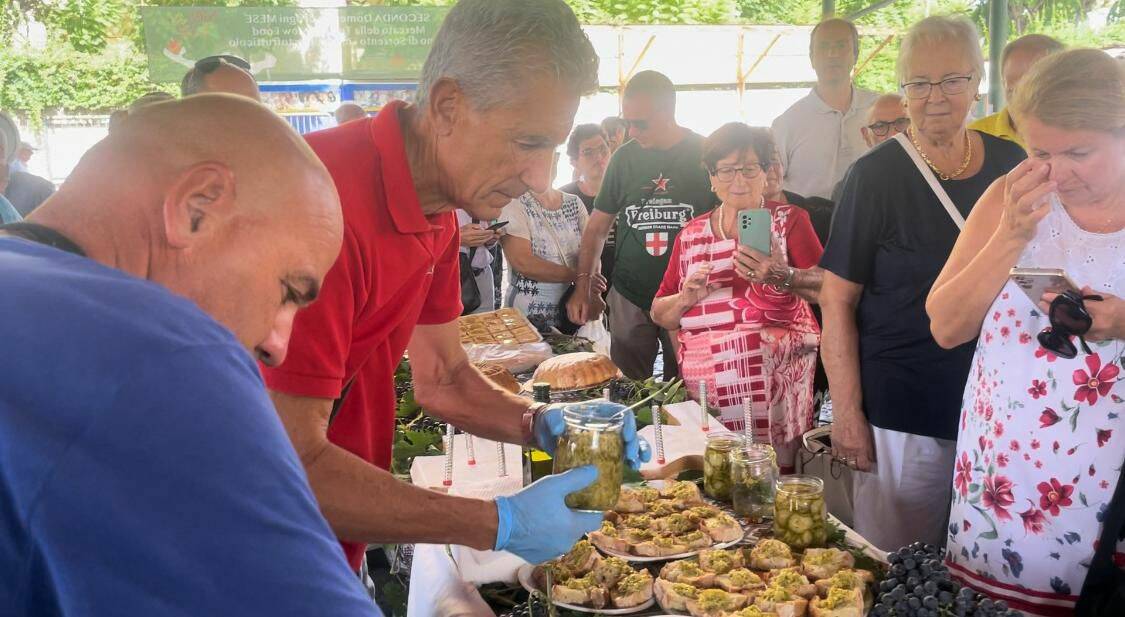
[{"xmin": 554, "ymin": 400, "xmax": 628, "ymax": 512}]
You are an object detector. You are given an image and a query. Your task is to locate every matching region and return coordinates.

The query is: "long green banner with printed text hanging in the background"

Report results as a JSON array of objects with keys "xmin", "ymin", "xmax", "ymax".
[{"xmin": 141, "ymin": 7, "xmax": 449, "ymax": 81}]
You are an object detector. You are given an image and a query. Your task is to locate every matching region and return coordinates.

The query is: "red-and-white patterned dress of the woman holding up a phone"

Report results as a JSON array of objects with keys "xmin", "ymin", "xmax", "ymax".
[{"xmin": 656, "ymin": 202, "xmax": 824, "ymax": 463}]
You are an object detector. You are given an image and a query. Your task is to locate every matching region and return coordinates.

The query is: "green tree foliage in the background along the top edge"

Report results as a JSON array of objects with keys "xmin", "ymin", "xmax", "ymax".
[{"xmin": 0, "ymin": 0, "xmax": 1125, "ymax": 124}]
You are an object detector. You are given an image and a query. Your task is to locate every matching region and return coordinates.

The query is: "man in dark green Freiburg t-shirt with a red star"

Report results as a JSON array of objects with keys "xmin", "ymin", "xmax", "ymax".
[{"xmin": 567, "ymin": 71, "xmax": 718, "ymax": 379}]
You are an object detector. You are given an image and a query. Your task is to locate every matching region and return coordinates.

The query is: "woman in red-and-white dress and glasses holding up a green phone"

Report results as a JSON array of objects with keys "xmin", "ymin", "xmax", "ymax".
[{"xmin": 653, "ymin": 123, "xmax": 821, "ymax": 470}]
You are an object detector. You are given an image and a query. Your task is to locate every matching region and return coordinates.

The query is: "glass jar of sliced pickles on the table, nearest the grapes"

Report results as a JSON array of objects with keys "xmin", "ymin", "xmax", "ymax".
[{"xmin": 774, "ymin": 475, "xmax": 828, "ymax": 551}]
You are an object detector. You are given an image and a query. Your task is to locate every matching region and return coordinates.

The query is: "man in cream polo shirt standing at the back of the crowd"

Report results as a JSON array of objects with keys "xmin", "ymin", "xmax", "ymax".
[{"xmin": 773, "ymin": 19, "xmax": 879, "ymax": 198}]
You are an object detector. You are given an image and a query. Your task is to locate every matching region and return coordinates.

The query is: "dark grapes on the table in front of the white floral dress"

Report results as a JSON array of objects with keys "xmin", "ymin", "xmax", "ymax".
[{"xmin": 871, "ymin": 542, "xmax": 1019, "ymax": 617}]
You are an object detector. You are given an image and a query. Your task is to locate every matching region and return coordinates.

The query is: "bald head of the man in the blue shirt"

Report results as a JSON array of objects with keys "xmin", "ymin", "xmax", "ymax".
[{"xmin": 32, "ymin": 95, "xmax": 343, "ymax": 364}]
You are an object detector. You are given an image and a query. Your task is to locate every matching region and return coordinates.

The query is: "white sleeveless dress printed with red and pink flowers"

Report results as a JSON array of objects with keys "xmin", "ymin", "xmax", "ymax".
[{"xmin": 947, "ymin": 204, "xmax": 1125, "ymax": 616}]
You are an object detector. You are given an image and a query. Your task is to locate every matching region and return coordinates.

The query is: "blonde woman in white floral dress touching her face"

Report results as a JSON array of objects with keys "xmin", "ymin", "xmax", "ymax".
[{"xmin": 927, "ymin": 50, "xmax": 1125, "ymax": 615}]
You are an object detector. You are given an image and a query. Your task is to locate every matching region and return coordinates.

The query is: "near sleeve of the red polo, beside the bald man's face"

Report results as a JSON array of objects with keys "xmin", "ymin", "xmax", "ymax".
[{"xmin": 261, "ymin": 227, "xmax": 367, "ymax": 399}]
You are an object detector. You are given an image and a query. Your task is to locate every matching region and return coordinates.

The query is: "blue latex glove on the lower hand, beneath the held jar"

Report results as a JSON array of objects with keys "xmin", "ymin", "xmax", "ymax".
[{"xmin": 496, "ymin": 465, "xmax": 602, "ymax": 563}]
